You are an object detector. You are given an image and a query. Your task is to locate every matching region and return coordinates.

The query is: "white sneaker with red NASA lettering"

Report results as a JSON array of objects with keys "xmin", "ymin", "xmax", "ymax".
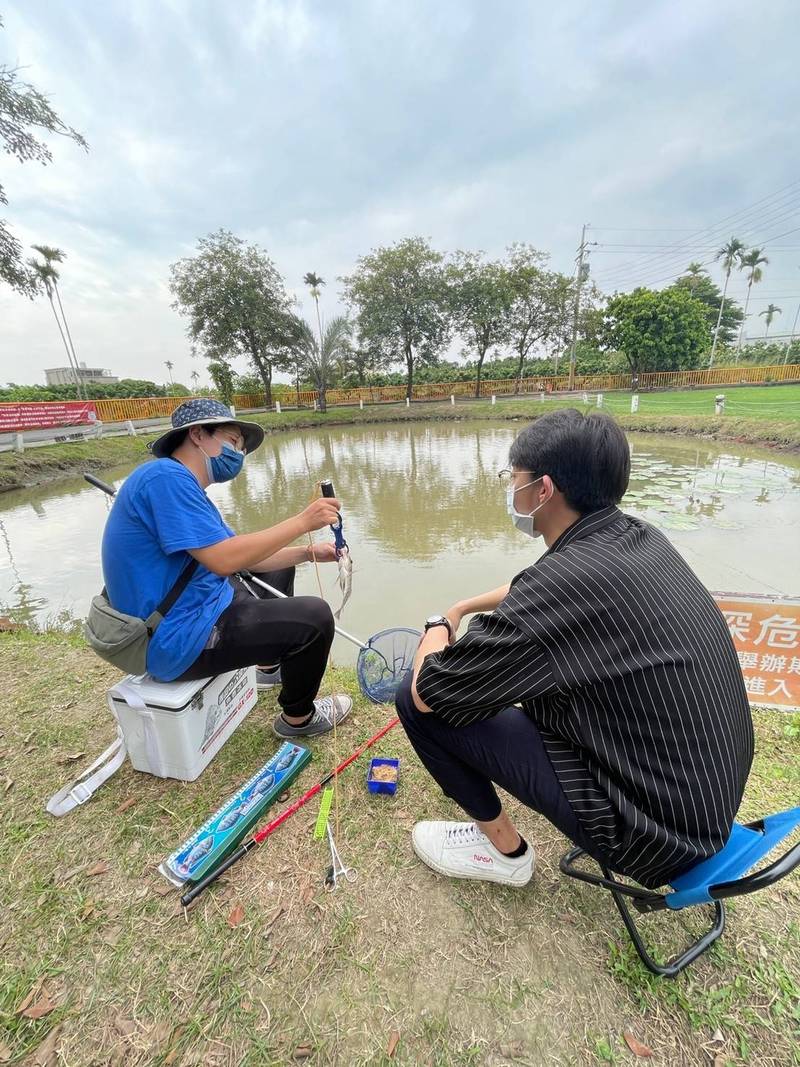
[{"xmin": 411, "ymin": 823, "xmax": 533, "ymax": 886}]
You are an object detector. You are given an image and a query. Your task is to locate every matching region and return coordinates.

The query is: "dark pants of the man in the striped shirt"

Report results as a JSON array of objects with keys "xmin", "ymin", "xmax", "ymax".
[{"xmin": 397, "ymin": 671, "xmax": 601, "ymax": 858}]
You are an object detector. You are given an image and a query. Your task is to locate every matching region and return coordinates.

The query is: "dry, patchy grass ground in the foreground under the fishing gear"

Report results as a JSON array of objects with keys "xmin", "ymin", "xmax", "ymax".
[{"xmin": 0, "ymin": 633, "xmax": 800, "ymax": 1067}]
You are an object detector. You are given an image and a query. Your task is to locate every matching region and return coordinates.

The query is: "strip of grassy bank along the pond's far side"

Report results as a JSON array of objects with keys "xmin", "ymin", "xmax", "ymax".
[{"xmin": 0, "ymin": 385, "xmax": 800, "ymax": 492}]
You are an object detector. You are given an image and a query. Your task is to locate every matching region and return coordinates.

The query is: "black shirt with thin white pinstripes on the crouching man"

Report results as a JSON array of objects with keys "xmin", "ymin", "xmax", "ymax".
[{"xmin": 417, "ymin": 508, "xmax": 753, "ymax": 887}]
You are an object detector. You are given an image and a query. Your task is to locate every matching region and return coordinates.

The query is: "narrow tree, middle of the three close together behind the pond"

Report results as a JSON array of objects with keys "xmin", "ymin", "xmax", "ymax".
[{"xmin": 446, "ymin": 252, "xmax": 514, "ymax": 397}]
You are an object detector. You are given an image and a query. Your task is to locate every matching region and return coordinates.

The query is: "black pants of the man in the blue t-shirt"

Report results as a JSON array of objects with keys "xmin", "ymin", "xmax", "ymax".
[{"xmin": 178, "ymin": 567, "xmax": 334, "ymax": 717}]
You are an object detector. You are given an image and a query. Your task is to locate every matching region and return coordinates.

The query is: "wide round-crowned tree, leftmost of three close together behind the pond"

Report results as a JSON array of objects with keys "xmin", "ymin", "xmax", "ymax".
[{"xmin": 341, "ymin": 237, "xmax": 450, "ymax": 399}]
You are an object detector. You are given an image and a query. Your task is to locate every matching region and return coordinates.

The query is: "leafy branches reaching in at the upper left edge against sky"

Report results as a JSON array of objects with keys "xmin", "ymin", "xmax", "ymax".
[{"xmin": 0, "ymin": 19, "xmax": 89, "ymax": 298}]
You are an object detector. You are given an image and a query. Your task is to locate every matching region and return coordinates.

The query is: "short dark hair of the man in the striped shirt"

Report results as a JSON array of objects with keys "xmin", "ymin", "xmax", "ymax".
[{"xmin": 509, "ymin": 408, "xmax": 630, "ymax": 515}]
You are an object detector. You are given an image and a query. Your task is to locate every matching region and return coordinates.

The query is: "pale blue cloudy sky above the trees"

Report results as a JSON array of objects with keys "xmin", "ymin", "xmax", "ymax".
[{"xmin": 0, "ymin": 0, "xmax": 800, "ymax": 392}]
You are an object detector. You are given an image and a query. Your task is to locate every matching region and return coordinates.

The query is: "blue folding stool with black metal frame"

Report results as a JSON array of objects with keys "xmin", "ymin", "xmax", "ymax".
[{"xmin": 560, "ymin": 808, "xmax": 800, "ymax": 978}]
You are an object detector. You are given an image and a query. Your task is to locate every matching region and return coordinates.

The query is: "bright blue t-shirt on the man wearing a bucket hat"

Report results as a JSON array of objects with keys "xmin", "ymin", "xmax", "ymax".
[{"xmin": 102, "ymin": 459, "xmax": 234, "ymax": 682}]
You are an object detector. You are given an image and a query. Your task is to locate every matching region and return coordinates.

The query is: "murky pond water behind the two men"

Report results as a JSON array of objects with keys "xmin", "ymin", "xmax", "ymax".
[{"xmin": 0, "ymin": 423, "xmax": 800, "ymax": 662}]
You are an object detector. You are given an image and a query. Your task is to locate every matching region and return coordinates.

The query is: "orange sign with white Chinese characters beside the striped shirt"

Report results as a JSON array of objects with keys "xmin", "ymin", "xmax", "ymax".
[{"xmin": 714, "ymin": 593, "xmax": 800, "ymax": 712}]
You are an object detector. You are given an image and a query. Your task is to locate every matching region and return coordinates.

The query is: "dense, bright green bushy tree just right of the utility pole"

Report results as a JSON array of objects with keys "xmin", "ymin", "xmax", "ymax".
[{"xmin": 598, "ymin": 287, "xmax": 708, "ymax": 378}]
